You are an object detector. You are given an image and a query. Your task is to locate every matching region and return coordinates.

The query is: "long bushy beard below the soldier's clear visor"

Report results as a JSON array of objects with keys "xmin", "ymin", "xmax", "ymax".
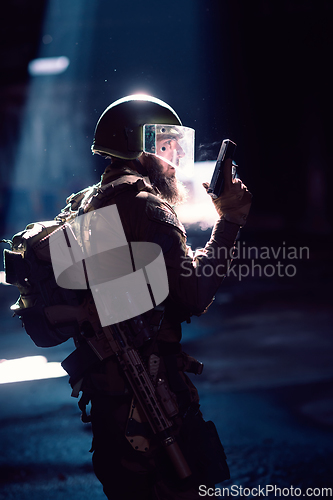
[{"xmin": 144, "ymin": 155, "xmax": 188, "ymax": 205}]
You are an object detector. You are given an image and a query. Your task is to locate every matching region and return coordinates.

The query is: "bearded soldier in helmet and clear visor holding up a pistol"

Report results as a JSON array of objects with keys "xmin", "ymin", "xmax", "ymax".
[{"xmin": 65, "ymin": 95, "xmax": 251, "ymax": 500}]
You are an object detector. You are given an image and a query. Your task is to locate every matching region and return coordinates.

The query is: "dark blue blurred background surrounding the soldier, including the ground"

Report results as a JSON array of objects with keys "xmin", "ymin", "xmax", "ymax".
[{"xmin": 0, "ymin": 0, "xmax": 333, "ymax": 499}]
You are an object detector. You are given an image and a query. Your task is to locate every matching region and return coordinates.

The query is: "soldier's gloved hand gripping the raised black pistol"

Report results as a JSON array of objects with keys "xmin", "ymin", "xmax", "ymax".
[{"xmin": 203, "ymin": 159, "xmax": 252, "ymax": 226}]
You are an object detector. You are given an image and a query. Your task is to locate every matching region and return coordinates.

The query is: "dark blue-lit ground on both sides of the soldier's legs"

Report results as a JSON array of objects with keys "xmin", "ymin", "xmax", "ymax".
[{"xmin": 0, "ymin": 229, "xmax": 333, "ymax": 500}]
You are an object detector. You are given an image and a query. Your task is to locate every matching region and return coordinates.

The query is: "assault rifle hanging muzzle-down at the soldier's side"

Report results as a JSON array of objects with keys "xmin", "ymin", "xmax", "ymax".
[{"xmin": 45, "ymin": 300, "xmax": 192, "ymax": 479}]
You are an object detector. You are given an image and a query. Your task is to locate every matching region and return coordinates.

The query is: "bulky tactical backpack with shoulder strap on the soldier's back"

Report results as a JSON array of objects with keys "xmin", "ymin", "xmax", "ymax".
[{"xmin": 4, "ymin": 175, "xmax": 153, "ymax": 347}]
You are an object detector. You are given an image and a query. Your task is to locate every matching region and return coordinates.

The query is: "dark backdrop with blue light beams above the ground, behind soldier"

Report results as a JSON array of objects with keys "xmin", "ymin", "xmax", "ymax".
[{"xmin": 0, "ymin": 0, "xmax": 333, "ymax": 236}]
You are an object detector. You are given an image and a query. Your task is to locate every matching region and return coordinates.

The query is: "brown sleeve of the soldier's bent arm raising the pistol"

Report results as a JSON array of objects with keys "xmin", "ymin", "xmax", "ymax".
[{"xmin": 142, "ymin": 195, "xmax": 239, "ymax": 315}]
